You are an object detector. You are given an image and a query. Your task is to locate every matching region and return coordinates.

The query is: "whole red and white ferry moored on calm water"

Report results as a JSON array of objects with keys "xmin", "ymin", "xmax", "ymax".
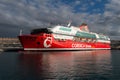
[{"xmin": 18, "ymin": 23, "xmax": 111, "ymax": 50}]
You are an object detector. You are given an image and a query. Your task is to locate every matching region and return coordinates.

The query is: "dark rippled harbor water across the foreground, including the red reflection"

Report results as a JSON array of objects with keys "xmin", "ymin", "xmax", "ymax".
[{"xmin": 0, "ymin": 50, "xmax": 120, "ymax": 80}]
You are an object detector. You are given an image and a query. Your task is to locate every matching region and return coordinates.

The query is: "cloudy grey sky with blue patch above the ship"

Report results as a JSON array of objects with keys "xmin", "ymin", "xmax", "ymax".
[{"xmin": 0, "ymin": 0, "xmax": 120, "ymax": 37}]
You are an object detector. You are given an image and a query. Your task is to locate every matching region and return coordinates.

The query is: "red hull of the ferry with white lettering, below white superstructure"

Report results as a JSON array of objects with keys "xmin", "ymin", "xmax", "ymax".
[{"xmin": 19, "ymin": 34, "xmax": 111, "ymax": 50}]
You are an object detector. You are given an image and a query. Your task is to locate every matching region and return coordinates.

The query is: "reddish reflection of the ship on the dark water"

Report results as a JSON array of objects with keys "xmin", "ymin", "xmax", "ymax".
[{"xmin": 19, "ymin": 50, "xmax": 112, "ymax": 80}]
